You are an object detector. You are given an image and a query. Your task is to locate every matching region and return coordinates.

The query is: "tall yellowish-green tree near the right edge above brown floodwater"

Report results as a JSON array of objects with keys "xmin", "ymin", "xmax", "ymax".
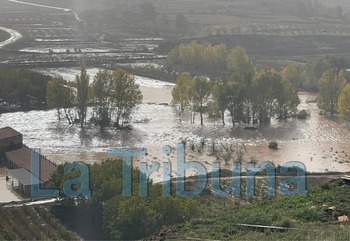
[{"xmin": 318, "ymin": 69, "xmax": 346, "ymax": 117}]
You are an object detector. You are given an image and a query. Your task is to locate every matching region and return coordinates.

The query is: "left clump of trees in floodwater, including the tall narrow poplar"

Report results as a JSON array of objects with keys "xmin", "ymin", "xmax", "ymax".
[{"xmin": 46, "ymin": 63, "xmax": 143, "ymax": 129}]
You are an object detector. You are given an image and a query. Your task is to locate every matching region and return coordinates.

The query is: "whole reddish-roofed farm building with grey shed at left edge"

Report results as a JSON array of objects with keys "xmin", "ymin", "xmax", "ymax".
[{"xmin": 0, "ymin": 127, "xmax": 57, "ymax": 196}]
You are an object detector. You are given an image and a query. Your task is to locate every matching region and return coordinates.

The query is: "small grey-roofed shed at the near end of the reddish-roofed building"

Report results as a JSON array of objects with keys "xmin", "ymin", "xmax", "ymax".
[{"xmin": 8, "ymin": 168, "xmax": 41, "ymax": 196}]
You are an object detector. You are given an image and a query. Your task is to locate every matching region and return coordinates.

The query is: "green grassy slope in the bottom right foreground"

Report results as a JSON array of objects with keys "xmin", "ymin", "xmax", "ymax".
[{"xmin": 153, "ymin": 178, "xmax": 350, "ymax": 240}]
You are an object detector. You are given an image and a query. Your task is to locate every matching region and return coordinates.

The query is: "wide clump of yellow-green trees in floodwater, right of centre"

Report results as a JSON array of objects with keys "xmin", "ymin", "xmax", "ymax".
[{"xmin": 172, "ymin": 46, "xmax": 300, "ymax": 125}]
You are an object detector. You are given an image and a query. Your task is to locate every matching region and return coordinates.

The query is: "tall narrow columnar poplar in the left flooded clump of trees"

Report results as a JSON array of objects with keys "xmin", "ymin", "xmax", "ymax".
[{"xmin": 75, "ymin": 63, "xmax": 90, "ymax": 128}]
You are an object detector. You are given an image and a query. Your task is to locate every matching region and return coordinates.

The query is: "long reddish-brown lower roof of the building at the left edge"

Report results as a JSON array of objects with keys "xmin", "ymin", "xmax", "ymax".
[{"xmin": 6, "ymin": 145, "xmax": 57, "ymax": 182}]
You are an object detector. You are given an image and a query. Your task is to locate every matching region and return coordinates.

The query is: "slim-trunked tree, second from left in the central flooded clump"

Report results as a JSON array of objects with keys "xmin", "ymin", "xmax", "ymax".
[{"xmin": 191, "ymin": 76, "xmax": 212, "ymax": 125}]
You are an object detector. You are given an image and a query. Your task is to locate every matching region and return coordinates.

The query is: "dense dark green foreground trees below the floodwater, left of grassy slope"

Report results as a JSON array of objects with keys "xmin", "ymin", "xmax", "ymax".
[{"xmin": 51, "ymin": 159, "xmax": 201, "ymax": 240}]
